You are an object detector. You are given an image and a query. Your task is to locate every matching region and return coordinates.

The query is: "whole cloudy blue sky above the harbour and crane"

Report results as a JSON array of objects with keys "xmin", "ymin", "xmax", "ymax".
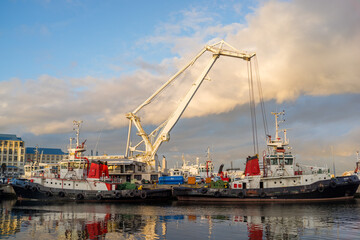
[{"xmin": 0, "ymin": 0, "xmax": 360, "ymax": 174}]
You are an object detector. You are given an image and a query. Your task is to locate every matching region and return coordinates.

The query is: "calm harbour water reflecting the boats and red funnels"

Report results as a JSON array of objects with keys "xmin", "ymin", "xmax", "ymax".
[{"xmin": 0, "ymin": 199, "xmax": 360, "ymax": 240}]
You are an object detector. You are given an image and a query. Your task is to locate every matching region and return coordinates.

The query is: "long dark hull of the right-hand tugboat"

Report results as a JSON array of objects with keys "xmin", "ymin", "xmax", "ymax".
[{"xmin": 173, "ymin": 176, "xmax": 360, "ymax": 202}]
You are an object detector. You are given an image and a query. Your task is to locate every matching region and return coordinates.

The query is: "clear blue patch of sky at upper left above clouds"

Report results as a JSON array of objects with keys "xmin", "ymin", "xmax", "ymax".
[{"xmin": 0, "ymin": 1, "xmax": 258, "ymax": 80}]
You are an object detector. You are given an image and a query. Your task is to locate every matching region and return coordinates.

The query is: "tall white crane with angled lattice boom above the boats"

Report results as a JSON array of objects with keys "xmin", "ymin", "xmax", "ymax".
[{"xmin": 125, "ymin": 40, "xmax": 256, "ymax": 169}]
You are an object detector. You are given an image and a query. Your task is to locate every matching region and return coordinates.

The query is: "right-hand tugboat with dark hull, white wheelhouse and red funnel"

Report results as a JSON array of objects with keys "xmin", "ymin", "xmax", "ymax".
[{"xmin": 173, "ymin": 112, "xmax": 360, "ymax": 202}]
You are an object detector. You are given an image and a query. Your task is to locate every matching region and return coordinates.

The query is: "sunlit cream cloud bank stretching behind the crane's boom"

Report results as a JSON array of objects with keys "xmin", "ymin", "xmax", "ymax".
[{"xmin": 0, "ymin": 0, "xmax": 360, "ymax": 139}]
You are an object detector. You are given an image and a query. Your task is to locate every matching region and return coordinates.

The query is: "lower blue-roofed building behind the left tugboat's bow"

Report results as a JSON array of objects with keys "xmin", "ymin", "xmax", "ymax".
[{"xmin": 25, "ymin": 147, "xmax": 66, "ymax": 164}]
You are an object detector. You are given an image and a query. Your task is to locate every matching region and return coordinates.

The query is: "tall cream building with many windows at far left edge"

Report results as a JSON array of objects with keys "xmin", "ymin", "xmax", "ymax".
[{"xmin": 0, "ymin": 134, "xmax": 25, "ymax": 176}]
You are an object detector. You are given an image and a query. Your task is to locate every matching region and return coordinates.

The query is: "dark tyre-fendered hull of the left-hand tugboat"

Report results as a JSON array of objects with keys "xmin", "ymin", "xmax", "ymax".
[{"xmin": 12, "ymin": 181, "xmax": 172, "ymax": 202}]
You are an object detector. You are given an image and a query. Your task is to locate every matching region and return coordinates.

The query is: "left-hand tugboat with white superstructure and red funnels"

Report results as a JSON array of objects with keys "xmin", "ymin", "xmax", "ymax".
[{"xmin": 11, "ymin": 121, "xmax": 171, "ymax": 201}]
